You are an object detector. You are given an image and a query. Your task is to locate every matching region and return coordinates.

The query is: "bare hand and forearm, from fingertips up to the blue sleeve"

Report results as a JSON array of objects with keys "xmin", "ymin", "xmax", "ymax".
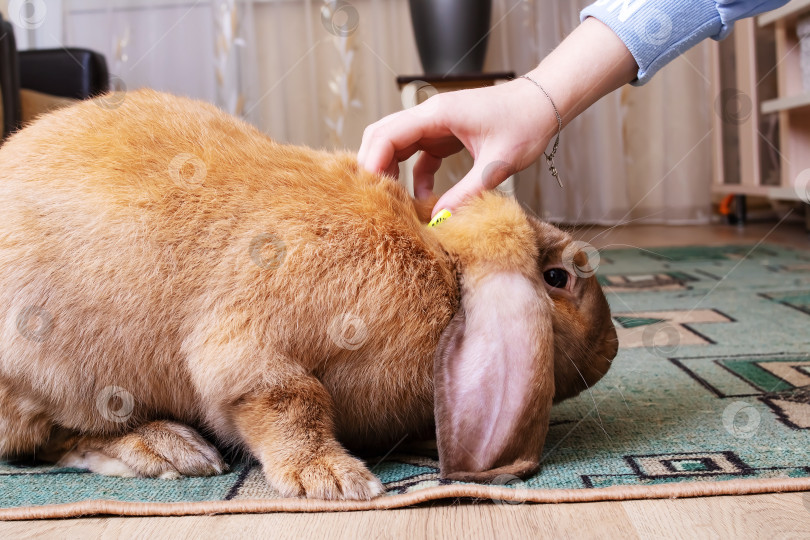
[{"xmin": 357, "ymin": 17, "xmax": 638, "ymax": 219}]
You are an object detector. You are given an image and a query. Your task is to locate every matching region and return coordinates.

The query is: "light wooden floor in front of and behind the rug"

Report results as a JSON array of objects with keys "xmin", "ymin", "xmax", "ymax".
[{"xmin": 0, "ymin": 218, "xmax": 810, "ymax": 539}]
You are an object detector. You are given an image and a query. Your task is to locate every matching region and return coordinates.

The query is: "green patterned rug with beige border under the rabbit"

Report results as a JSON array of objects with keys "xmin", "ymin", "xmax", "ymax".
[{"xmin": 0, "ymin": 245, "xmax": 810, "ymax": 519}]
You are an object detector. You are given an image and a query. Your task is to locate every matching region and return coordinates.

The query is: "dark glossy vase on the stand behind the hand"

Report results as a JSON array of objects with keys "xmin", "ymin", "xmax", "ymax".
[{"xmin": 409, "ymin": 0, "xmax": 492, "ymax": 75}]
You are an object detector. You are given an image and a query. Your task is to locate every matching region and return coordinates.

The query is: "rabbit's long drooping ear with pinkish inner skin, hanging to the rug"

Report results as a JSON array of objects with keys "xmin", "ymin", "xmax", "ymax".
[{"xmin": 434, "ymin": 271, "xmax": 554, "ymax": 482}]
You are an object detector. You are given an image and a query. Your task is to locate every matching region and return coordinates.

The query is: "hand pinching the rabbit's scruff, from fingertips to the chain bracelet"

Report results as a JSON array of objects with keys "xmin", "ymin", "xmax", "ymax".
[{"xmin": 357, "ymin": 79, "xmax": 557, "ymax": 215}]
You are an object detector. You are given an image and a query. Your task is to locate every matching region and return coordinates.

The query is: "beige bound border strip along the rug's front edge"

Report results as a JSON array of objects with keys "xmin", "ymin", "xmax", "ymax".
[{"xmin": 0, "ymin": 478, "xmax": 810, "ymax": 520}]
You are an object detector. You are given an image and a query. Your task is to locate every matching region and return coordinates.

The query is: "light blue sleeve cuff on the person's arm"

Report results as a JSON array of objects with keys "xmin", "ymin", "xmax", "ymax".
[{"xmin": 580, "ymin": 0, "xmax": 788, "ymax": 85}]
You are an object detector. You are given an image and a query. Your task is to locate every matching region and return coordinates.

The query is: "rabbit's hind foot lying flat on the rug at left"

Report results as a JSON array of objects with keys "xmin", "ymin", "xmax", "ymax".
[{"xmin": 59, "ymin": 421, "xmax": 228, "ymax": 479}]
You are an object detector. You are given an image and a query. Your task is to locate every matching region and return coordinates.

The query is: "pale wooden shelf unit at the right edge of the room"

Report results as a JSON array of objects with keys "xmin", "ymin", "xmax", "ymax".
[{"xmin": 712, "ymin": 0, "xmax": 810, "ymax": 215}]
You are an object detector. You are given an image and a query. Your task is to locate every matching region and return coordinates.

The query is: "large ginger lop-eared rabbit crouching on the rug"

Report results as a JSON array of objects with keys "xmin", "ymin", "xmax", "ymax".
[{"xmin": 0, "ymin": 91, "xmax": 617, "ymax": 499}]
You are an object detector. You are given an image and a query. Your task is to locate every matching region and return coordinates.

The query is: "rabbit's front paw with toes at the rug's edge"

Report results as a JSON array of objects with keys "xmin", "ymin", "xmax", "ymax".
[{"xmin": 265, "ymin": 451, "xmax": 384, "ymax": 500}]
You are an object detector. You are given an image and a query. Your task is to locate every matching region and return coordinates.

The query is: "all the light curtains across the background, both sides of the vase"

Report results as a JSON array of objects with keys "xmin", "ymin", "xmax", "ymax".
[{"xmin": 50, "ymin": 0, "xmax": 713, "ymax": 224}]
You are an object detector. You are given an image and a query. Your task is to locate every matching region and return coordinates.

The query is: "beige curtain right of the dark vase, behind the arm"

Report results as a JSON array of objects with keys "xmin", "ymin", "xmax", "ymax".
[{"xmin": 488, "ymin": 0, "xmax": 713, "ymax": 224}]
